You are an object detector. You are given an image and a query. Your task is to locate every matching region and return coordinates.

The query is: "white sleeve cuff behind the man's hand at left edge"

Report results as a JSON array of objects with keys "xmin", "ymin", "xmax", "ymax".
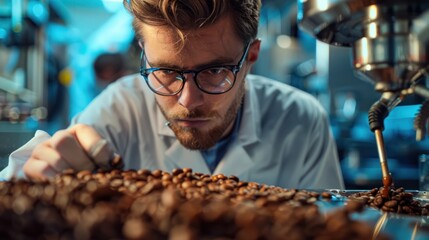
[{"xmin": 0, "ymin": 130, "xmax": 51, "ymax": 180}]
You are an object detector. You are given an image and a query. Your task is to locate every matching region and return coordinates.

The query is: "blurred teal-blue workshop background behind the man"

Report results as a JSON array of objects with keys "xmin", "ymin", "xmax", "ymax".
[{"xmin": 0, "ymin": 0, "xmax": 429, "ymax": 189}]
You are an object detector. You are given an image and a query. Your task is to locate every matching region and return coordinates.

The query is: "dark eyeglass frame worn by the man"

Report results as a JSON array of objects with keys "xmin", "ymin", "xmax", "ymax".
[{"xmin": 140, "ymin": 41, "xmax": 252, "ymax": 96}]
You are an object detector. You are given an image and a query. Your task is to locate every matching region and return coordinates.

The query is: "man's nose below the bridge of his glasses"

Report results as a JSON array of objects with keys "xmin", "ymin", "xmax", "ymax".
[{"xmin": 179, "ymin": 73, "xmax": 204, "ymax": 109}]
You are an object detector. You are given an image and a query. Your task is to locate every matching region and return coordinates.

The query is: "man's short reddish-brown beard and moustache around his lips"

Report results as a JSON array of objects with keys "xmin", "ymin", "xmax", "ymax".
[{"xmin": 157, "ymin": 81, "xmax": 245, "ymax": 150}]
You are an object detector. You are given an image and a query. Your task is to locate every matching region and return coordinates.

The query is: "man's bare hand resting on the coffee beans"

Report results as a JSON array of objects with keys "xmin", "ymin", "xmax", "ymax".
[{"xmin": 23, "ymin": 124, "xmax": 113, "ymax": 179}]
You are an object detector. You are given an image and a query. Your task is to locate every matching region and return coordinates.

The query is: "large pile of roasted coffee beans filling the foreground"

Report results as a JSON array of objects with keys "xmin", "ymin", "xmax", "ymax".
[{"xmin": 0, "ymin": 169, "xmax": 386, "ymax": 240}]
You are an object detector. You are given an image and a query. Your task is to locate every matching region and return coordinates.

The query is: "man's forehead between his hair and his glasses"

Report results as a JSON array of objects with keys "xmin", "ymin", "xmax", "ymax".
[{"xmin": 139, "ymin": 17, "xmax": 243, "ymax": 61}]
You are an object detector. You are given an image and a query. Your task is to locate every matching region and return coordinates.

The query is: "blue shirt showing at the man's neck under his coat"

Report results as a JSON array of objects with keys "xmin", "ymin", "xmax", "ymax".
[{"xmin": 201, "ymin": 107, "xmax": 242, "ymax": 173}]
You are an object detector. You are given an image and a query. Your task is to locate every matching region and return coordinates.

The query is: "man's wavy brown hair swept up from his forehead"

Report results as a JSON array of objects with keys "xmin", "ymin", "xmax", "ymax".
[{"xmin": 124, "ymin": 0, "xmax": 261, "ymax": 46}]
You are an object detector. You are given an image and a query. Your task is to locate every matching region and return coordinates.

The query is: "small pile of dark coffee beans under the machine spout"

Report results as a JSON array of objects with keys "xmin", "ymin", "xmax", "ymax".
[{"xmin": 348, "ymin": 187, "xmax": 429, "ymax": 216}]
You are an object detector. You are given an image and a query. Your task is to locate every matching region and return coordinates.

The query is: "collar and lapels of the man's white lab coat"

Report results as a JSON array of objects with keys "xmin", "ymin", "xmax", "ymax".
[{"xmin": 156, "ymin": 76, "xmax": 261, "ymax": 175}]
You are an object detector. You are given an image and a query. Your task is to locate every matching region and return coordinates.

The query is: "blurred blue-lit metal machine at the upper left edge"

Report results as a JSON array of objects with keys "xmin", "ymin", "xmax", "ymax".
[{"xmin": 0, "ymin": 0, "xmax": 49, "ymax": 123}]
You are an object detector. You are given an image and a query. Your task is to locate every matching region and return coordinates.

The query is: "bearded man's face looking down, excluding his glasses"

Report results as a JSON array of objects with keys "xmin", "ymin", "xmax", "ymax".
[{"xmin": 140, "ymin": 15, "xmax": 259, "ymax": 149}]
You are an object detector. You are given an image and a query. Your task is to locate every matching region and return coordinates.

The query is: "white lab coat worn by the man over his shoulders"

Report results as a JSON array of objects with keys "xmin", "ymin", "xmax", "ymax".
[{"xmin": 0, "ymin": 75, "xmax": 344, "ymax": 189}]
